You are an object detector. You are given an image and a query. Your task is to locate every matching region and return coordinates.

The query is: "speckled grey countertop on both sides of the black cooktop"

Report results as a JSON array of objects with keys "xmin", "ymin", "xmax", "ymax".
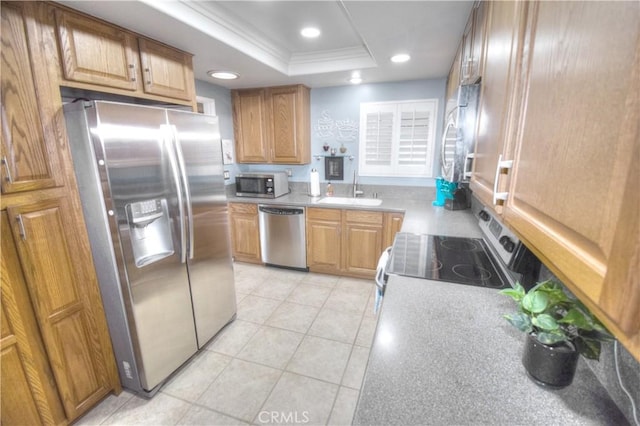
[{"xmin": 228, "ymin": 193, "xmax": 629, "ymax": 425}]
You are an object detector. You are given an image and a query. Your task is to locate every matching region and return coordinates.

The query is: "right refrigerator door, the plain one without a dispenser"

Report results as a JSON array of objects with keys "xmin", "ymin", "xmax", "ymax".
[{"xmin": 167, "ymin": 110, "xmax": 236, "ymax": 347}]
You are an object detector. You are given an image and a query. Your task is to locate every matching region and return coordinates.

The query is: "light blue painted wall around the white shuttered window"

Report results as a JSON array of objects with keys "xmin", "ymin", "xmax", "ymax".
[{"xmin": 196, "ymin": 78, "xmax": 446, "ymax": 186}]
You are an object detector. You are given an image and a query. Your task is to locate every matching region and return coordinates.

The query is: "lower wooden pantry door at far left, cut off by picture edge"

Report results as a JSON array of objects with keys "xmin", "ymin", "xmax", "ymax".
[{"xmin": 0, "ymin": 212, "xmax": 66, "ymax": 426}]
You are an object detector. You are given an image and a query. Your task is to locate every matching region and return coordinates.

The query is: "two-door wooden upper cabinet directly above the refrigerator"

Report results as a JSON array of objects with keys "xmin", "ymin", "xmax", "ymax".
[{"xmin": 55, "ymin": 7, "xmax": 195, "ymax": 105}]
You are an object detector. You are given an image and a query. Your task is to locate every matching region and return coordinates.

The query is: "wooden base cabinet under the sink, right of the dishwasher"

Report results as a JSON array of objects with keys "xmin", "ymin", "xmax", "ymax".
[{"xmin": 307, "ymin": 207, "xmax": 403, "ymax": 278}]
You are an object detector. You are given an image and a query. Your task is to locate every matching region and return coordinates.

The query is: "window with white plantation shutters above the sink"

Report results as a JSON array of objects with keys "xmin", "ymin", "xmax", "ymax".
[{"xmin": 359, "ymin": 99, "xmax": 438, "ymax": 177}]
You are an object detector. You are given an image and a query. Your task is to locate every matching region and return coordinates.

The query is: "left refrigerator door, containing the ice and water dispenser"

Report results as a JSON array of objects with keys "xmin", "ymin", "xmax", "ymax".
[{"xmin": 92, "ymin": 102, "xmax": 197, "ymax": 391}]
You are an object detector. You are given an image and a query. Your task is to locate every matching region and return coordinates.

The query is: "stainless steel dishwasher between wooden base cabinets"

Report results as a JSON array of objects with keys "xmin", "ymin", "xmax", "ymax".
[{"xmin": 258, "ymin": 204, "xmax": 308, "ymax": 271}]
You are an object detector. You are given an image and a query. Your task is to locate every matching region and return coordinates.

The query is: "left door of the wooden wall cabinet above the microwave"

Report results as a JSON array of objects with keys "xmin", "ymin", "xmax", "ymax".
[{"xmin": 231, "ymin": 89, "xmax": 269, "ymax": 163}]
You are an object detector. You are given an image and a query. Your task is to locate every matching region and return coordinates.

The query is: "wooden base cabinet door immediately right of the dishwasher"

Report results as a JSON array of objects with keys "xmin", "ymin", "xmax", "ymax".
[{"xmin": 307, "ymin": 208, "xmax": 342, "ymax": 274}]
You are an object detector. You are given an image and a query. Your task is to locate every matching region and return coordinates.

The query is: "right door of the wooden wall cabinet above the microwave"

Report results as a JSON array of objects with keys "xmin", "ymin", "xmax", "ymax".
[{"xmin": 267, "ymin": 86, "xmax": 310, "ymax": 164}]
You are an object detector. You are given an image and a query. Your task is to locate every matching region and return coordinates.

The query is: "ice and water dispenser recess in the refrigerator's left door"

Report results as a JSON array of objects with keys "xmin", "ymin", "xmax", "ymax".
[{"xmin": 126, "ymin": 198, "xmax": 174, "ymax": 268}]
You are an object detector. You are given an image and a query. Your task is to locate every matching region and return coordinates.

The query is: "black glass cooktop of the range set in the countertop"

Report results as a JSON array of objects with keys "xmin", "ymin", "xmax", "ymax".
[{"xmin": 387, "ymin": 232, "xmax": 510, "ymax": 288}]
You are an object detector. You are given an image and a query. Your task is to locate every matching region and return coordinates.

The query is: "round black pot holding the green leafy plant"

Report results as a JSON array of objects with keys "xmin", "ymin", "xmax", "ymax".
[{"xmin": 522, "ymin": 334, "xmax": 580, "ymax": 389}]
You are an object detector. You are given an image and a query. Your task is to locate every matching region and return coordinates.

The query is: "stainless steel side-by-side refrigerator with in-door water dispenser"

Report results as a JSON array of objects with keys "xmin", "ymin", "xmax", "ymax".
[{"xmin": 64, "ymin": 101, "xmax": 236, "ymax": 396}]
